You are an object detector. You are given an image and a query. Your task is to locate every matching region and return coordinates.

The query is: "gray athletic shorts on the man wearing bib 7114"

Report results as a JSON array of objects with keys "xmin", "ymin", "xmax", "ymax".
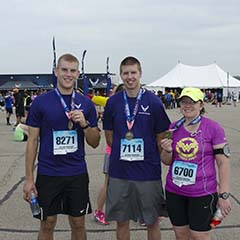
[{"xmin": 106, "ymin": 177, "xmax": 168, "ymax": 225}]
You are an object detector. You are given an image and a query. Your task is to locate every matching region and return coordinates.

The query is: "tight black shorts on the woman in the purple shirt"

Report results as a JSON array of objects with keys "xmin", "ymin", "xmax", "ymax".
[{"xmin": 166, "ymin": 191, "xmax": 218, "ymax": 232}]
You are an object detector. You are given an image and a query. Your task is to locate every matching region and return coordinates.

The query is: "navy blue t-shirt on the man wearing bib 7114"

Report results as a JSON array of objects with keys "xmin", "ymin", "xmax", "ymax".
[{"xmin": 103, "ymin": 90, "xmax": 170, "ymax": 181}]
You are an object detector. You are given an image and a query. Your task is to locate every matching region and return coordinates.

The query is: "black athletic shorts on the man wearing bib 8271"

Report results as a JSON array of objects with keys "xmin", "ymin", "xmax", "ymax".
[{"xmin": 35, "ymin": 173, "xmax": 92, "ymax": 220}]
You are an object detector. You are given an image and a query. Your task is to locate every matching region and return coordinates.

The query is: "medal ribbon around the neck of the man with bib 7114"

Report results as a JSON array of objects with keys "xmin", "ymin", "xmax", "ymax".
[{"xmin": 123, "ymin": 88, "xmax": 143, "ymax": 131}]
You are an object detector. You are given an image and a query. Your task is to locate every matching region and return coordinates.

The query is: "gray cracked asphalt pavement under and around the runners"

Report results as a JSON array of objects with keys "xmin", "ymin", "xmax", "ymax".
[{"xmin": 0, "ymin": 104, "xmax": 240, "ymax": 240}]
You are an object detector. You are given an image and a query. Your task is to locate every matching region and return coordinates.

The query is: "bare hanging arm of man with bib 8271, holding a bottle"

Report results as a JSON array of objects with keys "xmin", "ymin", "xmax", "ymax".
[{"xmin": 23, "ymin": 127, "xmax": 39, "ymax": 201}]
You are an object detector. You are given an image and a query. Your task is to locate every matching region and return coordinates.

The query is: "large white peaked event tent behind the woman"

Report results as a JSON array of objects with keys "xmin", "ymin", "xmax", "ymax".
[{"xmin": 145, "ymin": 63, "xmax": 240, "ymax": 96}]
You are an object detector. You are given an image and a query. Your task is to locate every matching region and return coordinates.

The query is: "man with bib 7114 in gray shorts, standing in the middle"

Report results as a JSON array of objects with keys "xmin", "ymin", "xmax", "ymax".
[{"xmin": 103, "ymin": 57, "xmax": 170, "ymax": 240}]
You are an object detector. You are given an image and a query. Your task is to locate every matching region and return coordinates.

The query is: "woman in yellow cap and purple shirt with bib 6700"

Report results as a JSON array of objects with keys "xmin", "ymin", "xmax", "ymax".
[{"xmin": 161, "ymin": 88, "xmax": 231, "ymax": 240}]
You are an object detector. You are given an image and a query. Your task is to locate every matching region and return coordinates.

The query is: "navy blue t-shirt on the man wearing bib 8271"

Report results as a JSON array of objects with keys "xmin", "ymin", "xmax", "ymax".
[{"xmin": 26, "ymin": 90, "xmax": 97, "ymax": 176}]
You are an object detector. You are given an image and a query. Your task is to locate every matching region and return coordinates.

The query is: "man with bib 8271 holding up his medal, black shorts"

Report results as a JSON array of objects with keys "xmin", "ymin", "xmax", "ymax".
[{"xmin": 23, "ymin": 54, "xmax": 100, "ymax": 240}]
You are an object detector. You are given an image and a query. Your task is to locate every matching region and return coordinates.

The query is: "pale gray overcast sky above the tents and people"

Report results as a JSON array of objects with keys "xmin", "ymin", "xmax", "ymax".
[{"xmin": 0, "ymin": 0, "xmax": 240, "ymax": 83}]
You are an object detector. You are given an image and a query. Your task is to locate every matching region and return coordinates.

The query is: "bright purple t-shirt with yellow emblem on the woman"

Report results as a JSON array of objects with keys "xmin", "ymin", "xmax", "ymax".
[{"xmin": 166, "ymin": 117, "xmax": 227, "ymax": 197}]
